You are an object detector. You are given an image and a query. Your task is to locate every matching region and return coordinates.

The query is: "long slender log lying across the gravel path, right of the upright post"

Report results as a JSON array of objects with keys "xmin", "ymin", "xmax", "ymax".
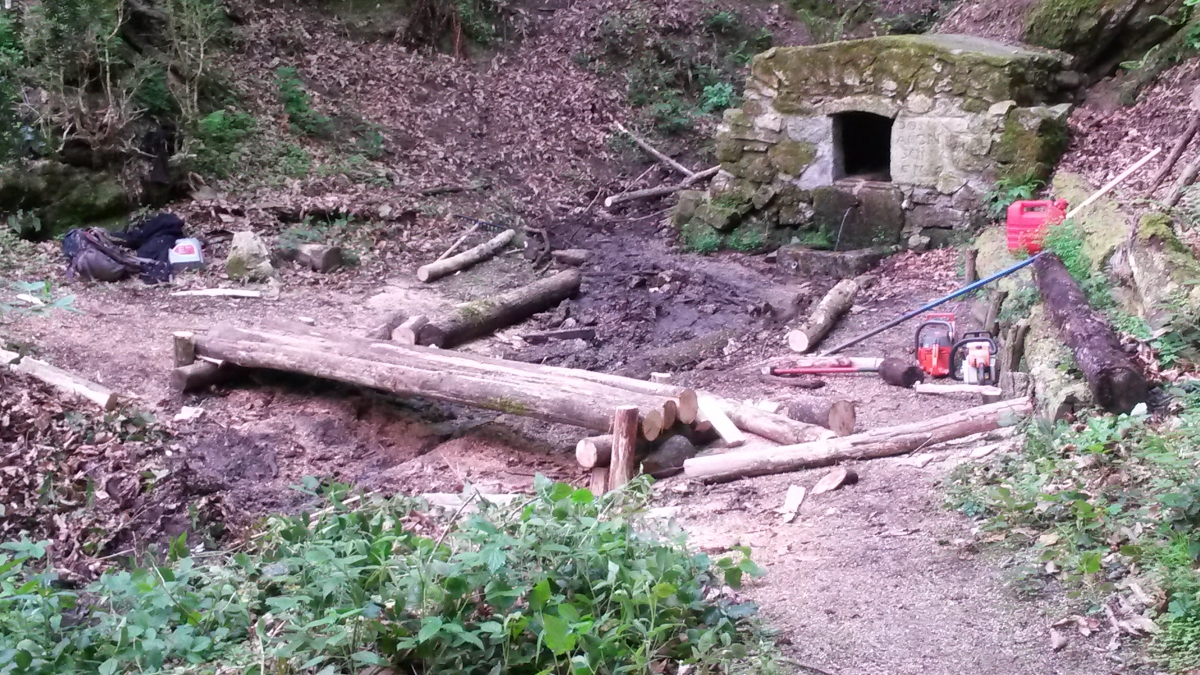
[{"xmin": 684, "ymin": 399, "xmax": 1033, "ymax": 482}]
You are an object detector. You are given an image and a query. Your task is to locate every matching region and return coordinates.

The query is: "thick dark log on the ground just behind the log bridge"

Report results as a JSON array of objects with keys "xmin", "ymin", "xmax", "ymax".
[{"xmin": 418, "ymin": 266, "xmax": 583, "ymax": 348}]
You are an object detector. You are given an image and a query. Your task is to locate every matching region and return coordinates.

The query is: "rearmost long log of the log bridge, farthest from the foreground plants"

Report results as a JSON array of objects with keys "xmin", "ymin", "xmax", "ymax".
[{"xmin": 209, "ymin": 324, "xmax": 698, "ymax": 426}]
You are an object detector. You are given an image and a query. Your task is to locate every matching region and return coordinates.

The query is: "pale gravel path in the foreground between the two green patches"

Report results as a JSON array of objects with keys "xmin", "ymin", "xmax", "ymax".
[{"xmin": 664, "ymin": 448, "xmax": 1120, "ymax": 675}]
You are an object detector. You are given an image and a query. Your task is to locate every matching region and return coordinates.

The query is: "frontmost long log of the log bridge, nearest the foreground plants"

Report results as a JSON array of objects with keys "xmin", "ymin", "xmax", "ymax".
[{"xmin": 196, "ymin": 336, "xmax": 665, "ymax": 441}]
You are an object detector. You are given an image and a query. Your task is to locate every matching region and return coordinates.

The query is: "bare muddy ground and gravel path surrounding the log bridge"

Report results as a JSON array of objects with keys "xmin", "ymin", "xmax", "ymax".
[{"xmin": 5, "ymin": 201, "xmax": 1142, "ymax": 675}]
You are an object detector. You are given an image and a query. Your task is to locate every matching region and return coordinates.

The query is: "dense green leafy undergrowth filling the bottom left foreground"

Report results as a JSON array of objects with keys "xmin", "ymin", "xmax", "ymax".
[{"xmin": 0, "ymin": 477, "xmax": 773, "ymax": 675}]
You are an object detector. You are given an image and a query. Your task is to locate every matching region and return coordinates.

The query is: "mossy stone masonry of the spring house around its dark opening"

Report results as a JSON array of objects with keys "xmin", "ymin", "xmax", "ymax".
[{"xmin": 676, "ymin": 35, "xmax": 1078, "ymax": 249}]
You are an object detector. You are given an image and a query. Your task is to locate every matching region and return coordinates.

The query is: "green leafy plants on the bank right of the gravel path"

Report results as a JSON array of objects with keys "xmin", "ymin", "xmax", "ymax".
[{"xmin": 947, "ymin": 386, "xmax": 1200, "ymax": 673}]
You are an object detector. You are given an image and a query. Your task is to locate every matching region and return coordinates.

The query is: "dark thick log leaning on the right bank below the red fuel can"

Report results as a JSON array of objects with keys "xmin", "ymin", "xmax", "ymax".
[{"xmin": 1033, "ymin": 253, "xmax": 1150, "ymax": 413}]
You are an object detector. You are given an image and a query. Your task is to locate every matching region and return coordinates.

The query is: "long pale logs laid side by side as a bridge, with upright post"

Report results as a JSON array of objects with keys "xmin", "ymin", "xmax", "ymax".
[{"xmin": 170, "ymin": 324, "xmax": 838, "ymax": 488}]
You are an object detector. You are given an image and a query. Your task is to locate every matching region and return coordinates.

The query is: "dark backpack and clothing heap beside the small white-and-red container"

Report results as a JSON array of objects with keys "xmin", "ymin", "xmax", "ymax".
[{"xmin": 62, "ymin": 214, "xmax": 184, "ymax": 285}]
